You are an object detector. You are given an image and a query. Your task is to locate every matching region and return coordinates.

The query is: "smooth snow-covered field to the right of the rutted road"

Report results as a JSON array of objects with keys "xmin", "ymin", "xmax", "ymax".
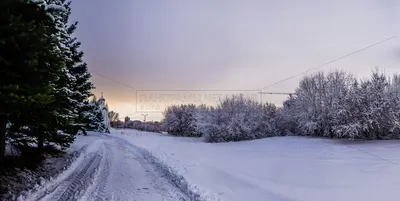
[{"xmin": 113, "ymin": 130, "xmax": 400, "ymax": 201}]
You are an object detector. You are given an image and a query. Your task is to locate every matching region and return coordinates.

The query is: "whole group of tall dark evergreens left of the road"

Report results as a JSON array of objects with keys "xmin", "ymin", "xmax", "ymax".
[{"xmin": 0, "ymin": 0, "xmax": 102, "ymax": 163}]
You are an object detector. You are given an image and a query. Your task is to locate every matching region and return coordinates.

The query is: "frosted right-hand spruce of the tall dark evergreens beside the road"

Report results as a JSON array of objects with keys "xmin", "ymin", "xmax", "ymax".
[{"xmin": 39, "ymin": 0, "xmax": 94, "ymax": 134}]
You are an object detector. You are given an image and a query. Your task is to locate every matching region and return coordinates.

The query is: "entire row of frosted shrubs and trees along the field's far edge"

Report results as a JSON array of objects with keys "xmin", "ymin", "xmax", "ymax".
[{"xmin": 163, "ymin": 70, "xmax": 400, "ymax": 142}]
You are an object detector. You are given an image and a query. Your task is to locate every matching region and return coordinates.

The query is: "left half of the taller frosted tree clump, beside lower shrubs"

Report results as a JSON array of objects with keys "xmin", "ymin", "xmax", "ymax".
[{"xmin": 281, "ymin": 71, "xmax": 353, "ymax": 137}]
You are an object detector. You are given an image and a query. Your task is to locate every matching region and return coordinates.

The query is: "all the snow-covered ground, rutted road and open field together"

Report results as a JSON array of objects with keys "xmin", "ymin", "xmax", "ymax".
[{"xmin": 19, "ymin": 130, "xmax": 400, "ymax": 201}]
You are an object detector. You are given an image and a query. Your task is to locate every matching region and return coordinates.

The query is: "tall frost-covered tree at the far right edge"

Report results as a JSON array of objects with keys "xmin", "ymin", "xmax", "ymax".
[{"xmin": 332, "ymin": 71, "xmax": 398, "ymax": 139}]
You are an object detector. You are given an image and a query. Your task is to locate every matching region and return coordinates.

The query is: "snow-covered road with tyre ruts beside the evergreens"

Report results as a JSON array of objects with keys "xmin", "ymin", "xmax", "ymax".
[{"xmin": 27, "ymin": 133, "xmax": 187, "ymax": 201}]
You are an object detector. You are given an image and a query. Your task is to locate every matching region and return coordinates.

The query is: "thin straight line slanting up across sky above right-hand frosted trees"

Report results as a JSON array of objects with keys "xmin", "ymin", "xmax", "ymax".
[{"xmin": 261, "ymin": 36, "xmax": 397, "ymax": 90}]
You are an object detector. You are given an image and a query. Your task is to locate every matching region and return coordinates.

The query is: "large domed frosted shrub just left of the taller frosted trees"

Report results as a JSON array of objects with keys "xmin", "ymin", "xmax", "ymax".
[{"xmin": 197, "ymin": 95, "xmax": 278, "ymax": 142}]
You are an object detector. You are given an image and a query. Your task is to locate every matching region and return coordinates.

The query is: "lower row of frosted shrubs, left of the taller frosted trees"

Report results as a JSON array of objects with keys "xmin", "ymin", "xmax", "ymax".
[{"xmin": 163, "ymin": 95, "xmax": 279, "ymax": 142}]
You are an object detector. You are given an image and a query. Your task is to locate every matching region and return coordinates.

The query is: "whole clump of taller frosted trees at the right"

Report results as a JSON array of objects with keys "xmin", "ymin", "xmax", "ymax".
[{"xmin": 280, "ymin": 71, "xmax": 400, "ymax": 139}]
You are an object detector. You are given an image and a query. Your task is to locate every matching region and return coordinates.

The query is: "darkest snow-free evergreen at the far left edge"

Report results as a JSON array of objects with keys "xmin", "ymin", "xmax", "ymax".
[{"xmin": 0, "ymin": 0, "xmax": 67, "ymax": 160}]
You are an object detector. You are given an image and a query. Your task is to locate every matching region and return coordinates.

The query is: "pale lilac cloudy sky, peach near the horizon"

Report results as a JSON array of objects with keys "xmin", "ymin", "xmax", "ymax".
[{"xmin": 72, "ymin": 0, "xmax": 400, "ymax": 120}]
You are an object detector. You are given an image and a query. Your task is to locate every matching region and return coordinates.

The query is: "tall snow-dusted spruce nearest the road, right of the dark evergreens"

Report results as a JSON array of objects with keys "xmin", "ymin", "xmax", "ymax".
[{"xmin": 37, "ymin": 0, "xmax": 94, "ymax": 146}]
